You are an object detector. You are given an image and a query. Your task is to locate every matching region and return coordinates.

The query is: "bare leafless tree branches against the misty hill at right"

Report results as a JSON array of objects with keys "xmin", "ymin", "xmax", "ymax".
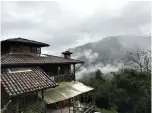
[{"xmin": 124, "ymin": 50, "xmax": 151, "ymax": 73}]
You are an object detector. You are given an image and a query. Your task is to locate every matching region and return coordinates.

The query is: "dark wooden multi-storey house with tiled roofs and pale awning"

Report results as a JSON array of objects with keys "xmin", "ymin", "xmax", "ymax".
[{"xmin": 1, "ymin": 38, "xmax": 93, "ymax": 113}]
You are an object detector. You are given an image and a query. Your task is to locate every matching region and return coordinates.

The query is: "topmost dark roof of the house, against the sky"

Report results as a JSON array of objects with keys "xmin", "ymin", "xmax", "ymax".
[{"xmin": 1, "ymin": 37, "xmax": 49, "ymax": 47}]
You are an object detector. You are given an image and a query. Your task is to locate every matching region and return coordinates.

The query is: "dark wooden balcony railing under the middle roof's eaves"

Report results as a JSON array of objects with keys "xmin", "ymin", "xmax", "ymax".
[{"xmin": 51, "ymin": 74, "xmax": 75, "ymax": 83}]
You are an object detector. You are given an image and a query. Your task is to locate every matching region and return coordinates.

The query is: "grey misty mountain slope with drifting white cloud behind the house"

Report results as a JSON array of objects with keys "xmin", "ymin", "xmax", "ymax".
[{"xmin": 69, "ymin": 35, "xmax": 151, "ymax": 77}]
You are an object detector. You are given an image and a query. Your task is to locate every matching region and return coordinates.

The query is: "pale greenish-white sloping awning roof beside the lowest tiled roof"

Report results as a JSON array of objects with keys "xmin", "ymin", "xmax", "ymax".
[{"xmin": 38, "ymin": 81, "xmax": 93, "ymax": 104}]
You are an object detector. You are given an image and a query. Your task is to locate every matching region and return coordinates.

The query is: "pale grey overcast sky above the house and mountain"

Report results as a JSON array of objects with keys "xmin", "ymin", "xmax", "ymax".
[{"xmin": 1, "ymin": 0, "xmax": 151, "ymax": 55}]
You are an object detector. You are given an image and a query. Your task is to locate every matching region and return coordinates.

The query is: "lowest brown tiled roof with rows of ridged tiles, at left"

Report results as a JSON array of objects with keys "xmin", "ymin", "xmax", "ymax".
[{"xmin": 1, "ymin": 67, "xmax": 57, "ymax": 96}]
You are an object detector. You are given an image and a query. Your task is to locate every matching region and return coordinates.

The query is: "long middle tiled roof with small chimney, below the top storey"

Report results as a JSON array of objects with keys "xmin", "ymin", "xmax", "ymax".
[{"xmin": 1, "ymin": 53, "xmax": 83, "ymax": 66}]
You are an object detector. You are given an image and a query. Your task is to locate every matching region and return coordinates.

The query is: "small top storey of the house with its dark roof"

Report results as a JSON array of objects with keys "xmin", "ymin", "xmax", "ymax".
[{"xmin": 1, "ymin": 38, "xmax": 49, "ymax": 54}]
